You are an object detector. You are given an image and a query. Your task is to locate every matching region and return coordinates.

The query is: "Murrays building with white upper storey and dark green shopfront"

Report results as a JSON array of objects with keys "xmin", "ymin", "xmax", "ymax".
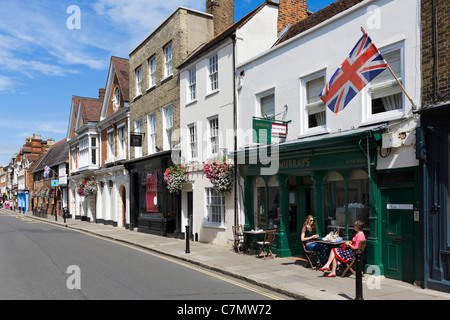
[{"xmin": 237, "ymin": 0, "xmax": 421, "ymax": 282}]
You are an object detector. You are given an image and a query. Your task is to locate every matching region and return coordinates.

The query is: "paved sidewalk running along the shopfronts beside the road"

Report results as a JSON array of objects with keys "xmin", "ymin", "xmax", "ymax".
[{"xmin": 6, "ymin": 209, "xmax": 450, "ymax": 300}]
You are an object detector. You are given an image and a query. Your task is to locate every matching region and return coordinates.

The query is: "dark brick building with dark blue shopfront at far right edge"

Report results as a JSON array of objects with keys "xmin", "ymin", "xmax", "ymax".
[{"xmin": 416, "ymin": 1, "xmax": 450, "ymax": 292}]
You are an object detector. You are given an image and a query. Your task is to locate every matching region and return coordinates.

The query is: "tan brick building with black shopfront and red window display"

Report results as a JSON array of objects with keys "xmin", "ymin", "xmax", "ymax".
[{"xmin": 125, "ymin": 7, "xmax": 213, "ymax": 235}]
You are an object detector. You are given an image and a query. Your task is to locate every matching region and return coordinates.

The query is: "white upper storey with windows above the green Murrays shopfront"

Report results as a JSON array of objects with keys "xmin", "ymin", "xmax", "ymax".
[{"xmin": 237, "ymin": 0, "xmax": 420, "ymax": 156}]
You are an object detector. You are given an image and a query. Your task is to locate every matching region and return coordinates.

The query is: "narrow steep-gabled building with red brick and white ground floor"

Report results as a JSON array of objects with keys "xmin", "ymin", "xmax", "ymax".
[{"xmin": 94, "ymin": 57, "xmax": 130, "ymax": 228}]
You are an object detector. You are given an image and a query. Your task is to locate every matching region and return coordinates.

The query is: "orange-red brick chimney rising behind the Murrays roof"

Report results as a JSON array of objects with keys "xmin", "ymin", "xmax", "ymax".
[{"xmin": 277, "ymin": 0, "xmax": 308, "ymax": 35}]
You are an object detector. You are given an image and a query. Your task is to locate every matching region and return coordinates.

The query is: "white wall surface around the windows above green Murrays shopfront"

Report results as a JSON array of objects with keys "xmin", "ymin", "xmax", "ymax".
[{"xmin": 238, "ymin": 0, "xmax": 421, "ymax": 169}]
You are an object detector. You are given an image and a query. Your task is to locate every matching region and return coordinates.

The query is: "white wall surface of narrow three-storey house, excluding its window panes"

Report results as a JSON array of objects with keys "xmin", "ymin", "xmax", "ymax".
[{"xmin": 180, "ymin": 5, "xmax": 278, "ymax": 245}]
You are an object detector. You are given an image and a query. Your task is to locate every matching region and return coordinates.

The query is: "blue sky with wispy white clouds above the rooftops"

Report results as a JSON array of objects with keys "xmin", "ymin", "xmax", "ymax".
[{"xmin": 0, "ymin": 0, "xmax": 334, "ymax": 166}]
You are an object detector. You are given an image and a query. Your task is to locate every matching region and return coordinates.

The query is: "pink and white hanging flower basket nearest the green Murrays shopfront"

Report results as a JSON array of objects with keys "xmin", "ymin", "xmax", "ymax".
[{"xmin": 203, "ymin": 157, "xmax": 233, "ymax": 195}]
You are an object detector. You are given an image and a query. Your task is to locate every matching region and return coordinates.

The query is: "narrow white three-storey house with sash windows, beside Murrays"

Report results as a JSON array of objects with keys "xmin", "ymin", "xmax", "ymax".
[{"xmin": 179, "ymin": 1, "xmax": 306, "ymax": 245}]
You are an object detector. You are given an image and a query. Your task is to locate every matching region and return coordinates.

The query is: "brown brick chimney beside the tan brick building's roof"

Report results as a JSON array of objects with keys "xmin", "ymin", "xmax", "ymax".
[{"xmin": 206, "ymin": 0, "xmax": 234, "ymax": 36}]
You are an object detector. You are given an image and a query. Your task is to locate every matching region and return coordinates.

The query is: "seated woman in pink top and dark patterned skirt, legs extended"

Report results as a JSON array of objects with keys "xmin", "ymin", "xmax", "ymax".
[{"xmin": 320, "ymin": 220, "xmax": 366, "ymax": 277}]
